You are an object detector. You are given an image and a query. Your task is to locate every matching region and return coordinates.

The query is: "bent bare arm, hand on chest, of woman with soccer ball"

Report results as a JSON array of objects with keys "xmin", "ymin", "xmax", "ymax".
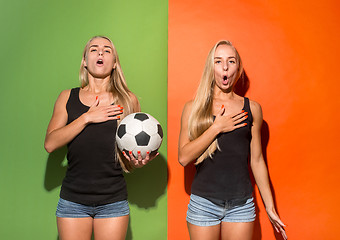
[{"xmin": 45, "ymin": 90, "xmax": 121, "ymax": 153}]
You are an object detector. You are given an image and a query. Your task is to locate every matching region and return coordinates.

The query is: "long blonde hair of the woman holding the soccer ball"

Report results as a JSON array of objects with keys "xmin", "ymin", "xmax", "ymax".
[{"xmin": 79, "ymin": 36, "xmax": 136, "ymax": 172}]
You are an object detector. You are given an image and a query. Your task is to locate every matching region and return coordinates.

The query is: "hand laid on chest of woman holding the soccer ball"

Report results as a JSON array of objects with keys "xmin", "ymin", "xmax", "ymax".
[{"xmin": 85, "ymin": 98, "xmax": 123, "ymax": 123}]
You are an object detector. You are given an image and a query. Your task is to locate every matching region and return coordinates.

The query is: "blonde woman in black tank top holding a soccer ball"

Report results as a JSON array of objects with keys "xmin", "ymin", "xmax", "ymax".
[{"xmin": 45, "ymin": 36, "xmax": 155, "ymax": 240}]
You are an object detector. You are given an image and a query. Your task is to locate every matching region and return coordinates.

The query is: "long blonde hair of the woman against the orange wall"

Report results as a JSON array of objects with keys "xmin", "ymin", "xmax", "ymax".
[{"xmin": 188, "ymin": 40, "xmax": 243, "ymax": 164}]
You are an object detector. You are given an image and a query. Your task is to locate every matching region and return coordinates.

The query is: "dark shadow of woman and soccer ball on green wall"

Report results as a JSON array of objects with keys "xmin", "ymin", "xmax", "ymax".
[{"xmin": 44, "ymin": 147, "xmax": 168, "ymax": 240}]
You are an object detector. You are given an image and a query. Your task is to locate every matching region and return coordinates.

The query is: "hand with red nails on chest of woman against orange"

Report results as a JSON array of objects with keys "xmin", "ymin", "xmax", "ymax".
[{"xmin": 213, "ymin": 105, "xmax": 248, "ymax": 133}]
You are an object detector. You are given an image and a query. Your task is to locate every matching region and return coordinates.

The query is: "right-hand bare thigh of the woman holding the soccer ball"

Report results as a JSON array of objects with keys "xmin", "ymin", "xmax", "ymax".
[{"xmin": 93, "ymin": 215, "xmax": 129, "ymax": 240}]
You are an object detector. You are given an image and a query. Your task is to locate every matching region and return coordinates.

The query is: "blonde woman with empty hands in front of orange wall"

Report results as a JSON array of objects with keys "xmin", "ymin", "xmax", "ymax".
[{"xmin": 178, "ymin": 41, "xmax": 287, "ymax": 240}]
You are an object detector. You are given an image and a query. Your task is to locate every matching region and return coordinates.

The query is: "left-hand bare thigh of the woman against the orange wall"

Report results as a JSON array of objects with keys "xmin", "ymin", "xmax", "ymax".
[{"xmin": 188, "ymin": 223, "xmax": 221, "ymax": 240}]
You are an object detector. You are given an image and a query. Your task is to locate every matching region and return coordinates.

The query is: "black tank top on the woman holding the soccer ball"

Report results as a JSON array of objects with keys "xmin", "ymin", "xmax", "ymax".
[{"xmin": 60, "ymin": 88, "xmax": 127, "ymax": 206}]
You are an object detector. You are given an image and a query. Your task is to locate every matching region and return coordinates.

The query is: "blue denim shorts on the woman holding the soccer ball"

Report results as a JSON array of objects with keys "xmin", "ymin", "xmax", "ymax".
[{"xmin": 56, "ymin": 198, "xmax": 130, "ymax": 218}]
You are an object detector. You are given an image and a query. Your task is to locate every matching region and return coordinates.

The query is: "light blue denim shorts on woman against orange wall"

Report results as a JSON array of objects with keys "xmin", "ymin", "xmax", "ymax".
[{"xmin": 187, "ymin": 194, "xmax": 256, "ymax": 226}]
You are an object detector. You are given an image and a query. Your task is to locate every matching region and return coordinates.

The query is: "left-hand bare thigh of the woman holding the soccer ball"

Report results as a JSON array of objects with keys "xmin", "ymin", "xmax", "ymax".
[{"xmin": 57, "ymin": 217, "xmax": 93, "ymax": 240}]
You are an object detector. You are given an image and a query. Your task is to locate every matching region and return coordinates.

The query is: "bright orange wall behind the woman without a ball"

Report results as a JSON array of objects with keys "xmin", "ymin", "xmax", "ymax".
[{"xmin": 168, "ymin": 0, "xmax": 340, "ymax": 240}]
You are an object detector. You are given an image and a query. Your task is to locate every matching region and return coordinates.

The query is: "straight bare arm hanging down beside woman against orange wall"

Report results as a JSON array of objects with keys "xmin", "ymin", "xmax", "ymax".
[{"xmin": 250, "ymin": 102, "xmax": 287, "ymax": 239}]
